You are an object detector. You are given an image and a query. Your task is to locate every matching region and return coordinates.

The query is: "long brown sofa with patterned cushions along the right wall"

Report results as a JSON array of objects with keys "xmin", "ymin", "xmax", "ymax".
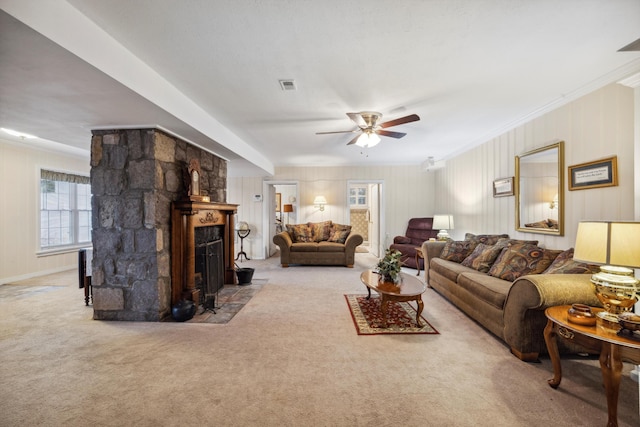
[{"xmin": 422, "ymin": 233, "xmax": 601, "ymax": 361}]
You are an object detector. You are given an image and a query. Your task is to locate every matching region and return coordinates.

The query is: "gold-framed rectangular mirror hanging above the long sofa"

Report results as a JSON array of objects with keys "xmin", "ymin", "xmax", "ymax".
[{"xmin": 515, "ymin": 141, "xmax": 564, "ymax": 236}]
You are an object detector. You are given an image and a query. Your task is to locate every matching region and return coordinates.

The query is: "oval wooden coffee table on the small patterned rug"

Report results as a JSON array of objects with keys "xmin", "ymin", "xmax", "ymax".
[{"xmin": 360, "ymin": 270, "xmax": 427, "ymax": 328}]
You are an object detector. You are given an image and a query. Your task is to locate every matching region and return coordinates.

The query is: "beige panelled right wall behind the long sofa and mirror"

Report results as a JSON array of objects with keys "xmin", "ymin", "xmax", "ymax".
[{"xmin": 436, "ymin": 84, "xmax": 634, "ymax": 249}]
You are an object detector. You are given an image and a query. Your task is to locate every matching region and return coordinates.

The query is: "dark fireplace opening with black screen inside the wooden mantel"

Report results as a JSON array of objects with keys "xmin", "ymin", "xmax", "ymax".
[{"xmin": 194, "ymin": 225, "xmax": 224, "ymax": 312}]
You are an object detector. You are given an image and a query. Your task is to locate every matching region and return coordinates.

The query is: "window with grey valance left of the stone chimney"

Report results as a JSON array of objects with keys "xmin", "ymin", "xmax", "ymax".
[{"xmin": 40, "ymin": 169, "xmax": 91, "ymax": 250}]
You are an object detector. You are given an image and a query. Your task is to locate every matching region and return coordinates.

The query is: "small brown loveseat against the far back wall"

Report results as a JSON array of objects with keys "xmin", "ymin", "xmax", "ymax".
[{"xmin": 273, "ymin": 221, "xmax": 363, "ymax": 268}]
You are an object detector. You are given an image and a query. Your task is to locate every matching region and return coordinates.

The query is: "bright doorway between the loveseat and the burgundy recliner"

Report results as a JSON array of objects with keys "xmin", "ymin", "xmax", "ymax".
[{"xmin": 347, "ymin": 180, "xmax": 384, "ymax": 257}]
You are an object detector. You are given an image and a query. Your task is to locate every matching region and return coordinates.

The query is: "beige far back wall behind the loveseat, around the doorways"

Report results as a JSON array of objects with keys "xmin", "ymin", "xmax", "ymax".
[{"xmin": 227, "ymin": 165, "xmax": 438, "ymax": 258}]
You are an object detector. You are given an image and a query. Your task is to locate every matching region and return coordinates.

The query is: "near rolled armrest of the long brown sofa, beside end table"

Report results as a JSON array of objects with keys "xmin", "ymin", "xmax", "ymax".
[{"xmin": 503, "ymin": 274, "xmax": 602, "ymax": 355}]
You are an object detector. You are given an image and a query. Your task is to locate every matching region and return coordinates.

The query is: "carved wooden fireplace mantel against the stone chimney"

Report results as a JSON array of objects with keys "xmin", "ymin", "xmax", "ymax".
[{"xmin": 171, "ymin": 200, "xmax": 238, "ymax": 306}]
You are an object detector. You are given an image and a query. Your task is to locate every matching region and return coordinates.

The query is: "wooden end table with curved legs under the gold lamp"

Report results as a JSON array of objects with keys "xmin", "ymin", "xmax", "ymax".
[{"xmin": 544, "ymin": 305, "xmax": 640, "ymax": 427}]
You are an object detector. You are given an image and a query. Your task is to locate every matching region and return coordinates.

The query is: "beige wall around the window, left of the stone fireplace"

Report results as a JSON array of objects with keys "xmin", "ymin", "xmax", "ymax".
[{"xmin": 0, "ymin": 139, "xmax": 89, "ymax": 283}]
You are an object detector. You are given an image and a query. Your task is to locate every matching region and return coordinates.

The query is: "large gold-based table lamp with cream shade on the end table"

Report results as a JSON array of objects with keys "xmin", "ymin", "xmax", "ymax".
[{"xmin": 573, "ymin": 221, "xmax": 640, "ymax": 323}]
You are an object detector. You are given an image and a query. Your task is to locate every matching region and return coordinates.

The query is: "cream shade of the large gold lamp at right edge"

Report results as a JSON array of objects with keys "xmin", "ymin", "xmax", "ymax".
[{"xmin": 573, "ymin": 221, "xmax": 640, "ymax": 268}]
